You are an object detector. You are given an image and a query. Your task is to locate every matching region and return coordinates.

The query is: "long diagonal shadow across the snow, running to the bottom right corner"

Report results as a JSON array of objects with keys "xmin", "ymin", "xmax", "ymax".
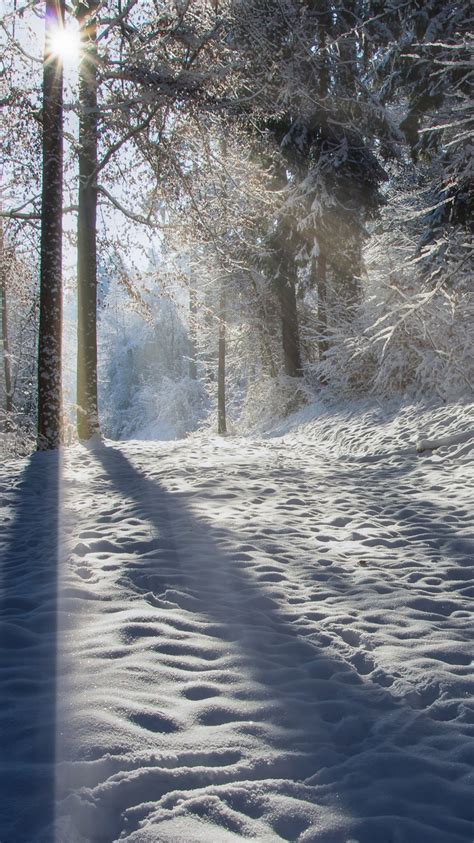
[{"xmin": 90, "ymin": 448, "xmax": 472, "ymax": 843}]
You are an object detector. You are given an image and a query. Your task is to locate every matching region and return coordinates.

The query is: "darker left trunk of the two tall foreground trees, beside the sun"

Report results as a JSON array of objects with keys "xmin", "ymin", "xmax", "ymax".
[{"xmin": 37, "ymin": 0, "xmax": 65, "ymax": 450}]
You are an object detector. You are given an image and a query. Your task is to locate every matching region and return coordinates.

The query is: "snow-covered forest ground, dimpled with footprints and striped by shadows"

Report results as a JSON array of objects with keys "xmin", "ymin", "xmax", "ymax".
[{"xmin": 0, "ymin": 398, "xmax": 474, "ymax": 843}]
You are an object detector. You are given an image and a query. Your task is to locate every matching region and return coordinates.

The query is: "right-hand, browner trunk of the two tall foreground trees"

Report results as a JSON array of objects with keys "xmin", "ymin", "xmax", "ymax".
[{"xmin": 77, "ymin": 0, "xmax": 100, "ymax": 439}]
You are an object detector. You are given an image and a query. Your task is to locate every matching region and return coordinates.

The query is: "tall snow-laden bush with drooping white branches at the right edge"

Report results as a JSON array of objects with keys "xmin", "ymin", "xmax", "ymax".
[{"xmin": 309, "ymin": 167, "xmax": 474, "ymax": 401}]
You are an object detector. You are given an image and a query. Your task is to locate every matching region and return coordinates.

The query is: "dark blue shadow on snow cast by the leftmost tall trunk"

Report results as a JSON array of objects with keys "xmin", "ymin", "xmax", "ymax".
[{"xmin": 0, "ymin": 453, "xmax": 60, "ymax": 843}]
